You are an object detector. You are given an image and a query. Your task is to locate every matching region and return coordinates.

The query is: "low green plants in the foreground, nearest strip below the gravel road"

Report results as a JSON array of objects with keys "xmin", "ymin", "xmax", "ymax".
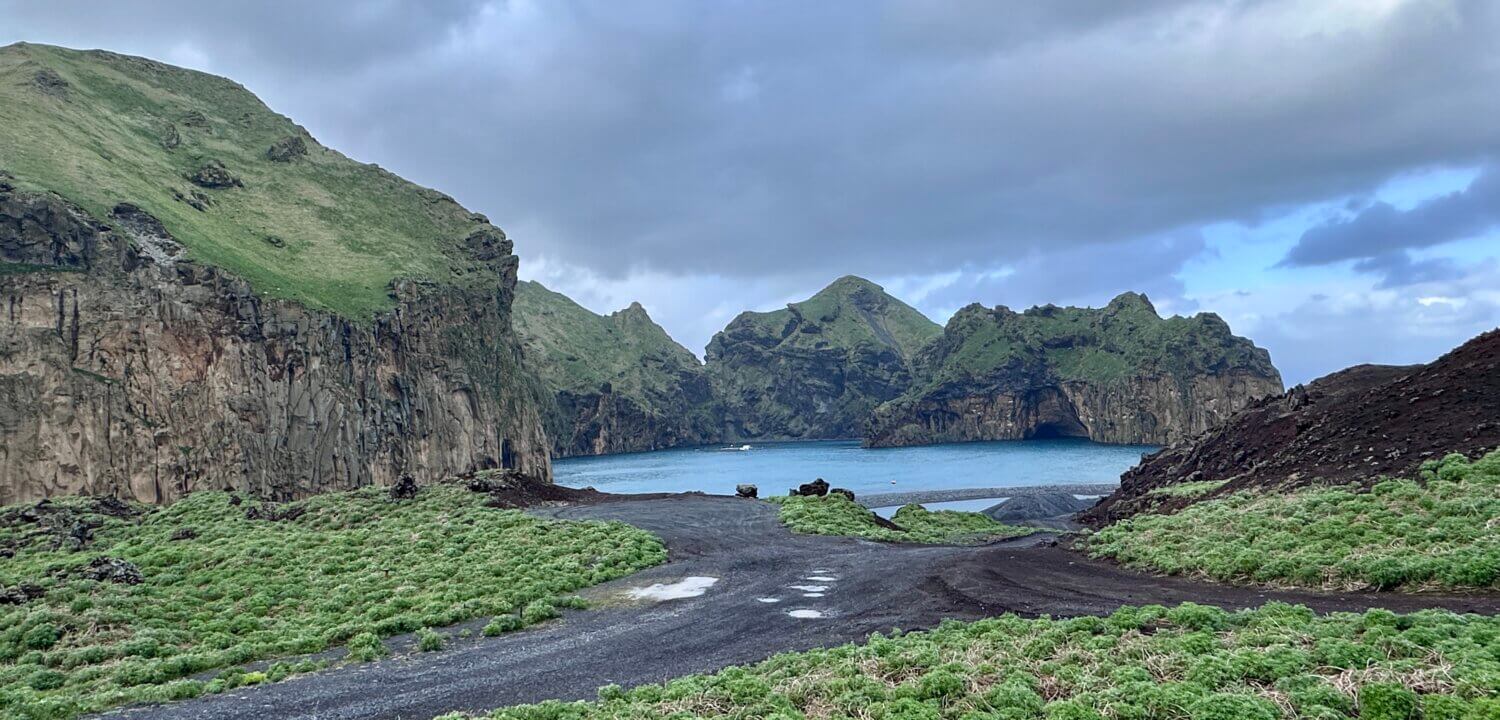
[{"xmin": 446, "ymin": 605, "xmax": 1500, "ymax": 720}]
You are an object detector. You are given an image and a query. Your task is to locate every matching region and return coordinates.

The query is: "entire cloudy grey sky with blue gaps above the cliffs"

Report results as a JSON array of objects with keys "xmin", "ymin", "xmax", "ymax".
[{"xmin": 0, "ymin": 0, "xmax": 1500, "ymax": 384}]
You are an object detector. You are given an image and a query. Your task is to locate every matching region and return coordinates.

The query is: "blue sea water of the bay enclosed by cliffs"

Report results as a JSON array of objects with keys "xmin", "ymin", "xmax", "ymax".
[{"xmin": 554, "ymin": 440, "xmax": 1155, "ymax": 497}]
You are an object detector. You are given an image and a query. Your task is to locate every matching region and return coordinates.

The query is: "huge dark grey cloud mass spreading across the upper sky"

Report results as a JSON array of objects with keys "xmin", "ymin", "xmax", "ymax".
[{"xmin": 0, "ymin": 0, "xmax": 1500, "ymax": 287}]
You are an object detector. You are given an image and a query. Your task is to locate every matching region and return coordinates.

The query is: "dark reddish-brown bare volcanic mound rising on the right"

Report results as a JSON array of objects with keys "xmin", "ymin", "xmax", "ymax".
[{"xmin": 1080, "ymin": 330, "xmax": 1500, "ymax": 525}]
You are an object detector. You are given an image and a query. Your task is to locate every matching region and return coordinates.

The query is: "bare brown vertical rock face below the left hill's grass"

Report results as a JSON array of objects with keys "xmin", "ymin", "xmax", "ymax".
[{"xmin": 0, "ymin": 191, "xmax": 551, "ymax": 503}]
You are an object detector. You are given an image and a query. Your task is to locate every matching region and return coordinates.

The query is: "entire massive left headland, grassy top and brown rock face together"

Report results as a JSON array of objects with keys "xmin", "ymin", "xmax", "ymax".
[{"xmin": 0, "ymin": 45, "xmax": 551, "ymax": 503}]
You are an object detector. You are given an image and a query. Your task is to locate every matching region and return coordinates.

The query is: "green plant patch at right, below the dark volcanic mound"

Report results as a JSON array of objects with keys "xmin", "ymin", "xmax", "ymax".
[{"xmin": 1088, "ymin": 450, "xmax": 1500, "ymax": 590}]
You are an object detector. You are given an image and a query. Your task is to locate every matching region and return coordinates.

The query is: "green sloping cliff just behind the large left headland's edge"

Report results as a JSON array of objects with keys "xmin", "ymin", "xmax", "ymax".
[{"xmin": 515, "ymin": 282, "xmax": 722, "ymax": 458}]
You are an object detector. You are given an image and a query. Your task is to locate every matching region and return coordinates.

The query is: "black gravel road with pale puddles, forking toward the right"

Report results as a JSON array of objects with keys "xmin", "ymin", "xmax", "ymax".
[{"xmin": 111, "ymin": 497, "xmax": 1500, "ymax": 720}]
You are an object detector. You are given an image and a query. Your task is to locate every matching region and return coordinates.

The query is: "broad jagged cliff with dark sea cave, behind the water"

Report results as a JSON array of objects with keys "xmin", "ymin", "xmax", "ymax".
[{"xmin": 866, "ymin": 293, "xmax": 1281, "ymax": 447}]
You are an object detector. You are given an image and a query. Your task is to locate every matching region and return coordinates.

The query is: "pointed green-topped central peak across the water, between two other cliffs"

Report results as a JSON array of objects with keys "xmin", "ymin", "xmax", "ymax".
[{"xmin": 707, "ymin": 276, "xmax": 942, "ymax": 440}]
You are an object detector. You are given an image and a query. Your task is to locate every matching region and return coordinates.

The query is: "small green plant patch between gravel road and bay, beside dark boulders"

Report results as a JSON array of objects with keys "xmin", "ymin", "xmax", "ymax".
[{"xmin": 770, "ymin": 494, "xmax": 1032, "ymax": 545}]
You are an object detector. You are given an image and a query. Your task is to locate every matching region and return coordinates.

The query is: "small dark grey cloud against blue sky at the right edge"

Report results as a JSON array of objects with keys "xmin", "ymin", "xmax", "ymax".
[{"xmin": 1281, "ymin": 165, "xmax": 1500, "ymax": 271}]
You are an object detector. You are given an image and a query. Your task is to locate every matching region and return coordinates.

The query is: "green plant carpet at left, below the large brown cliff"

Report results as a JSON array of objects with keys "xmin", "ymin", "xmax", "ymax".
[{"xmin": 0, "ymin": 485, "xmax": 666, "ymax": 717}]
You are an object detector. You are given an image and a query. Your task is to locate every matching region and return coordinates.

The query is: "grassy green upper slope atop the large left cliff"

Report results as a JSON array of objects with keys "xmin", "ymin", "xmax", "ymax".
[{"xmin": 0, "ymin": 44, "xmax": 495, "ymax": 318}]
